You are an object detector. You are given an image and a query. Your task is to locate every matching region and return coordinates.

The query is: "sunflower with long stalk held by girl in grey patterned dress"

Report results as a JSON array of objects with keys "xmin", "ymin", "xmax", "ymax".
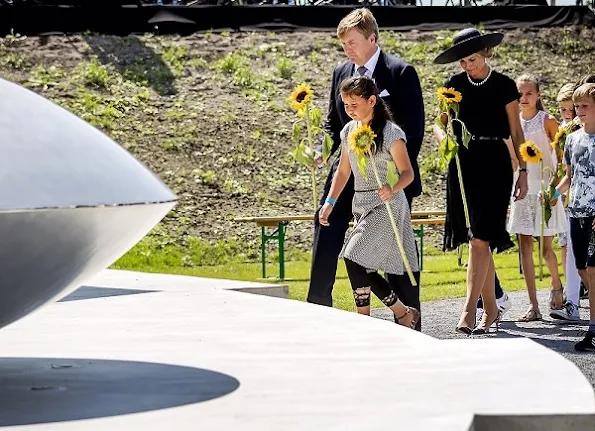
[{"xmin": 349, "ymin": 125, "xmax": 417, "ymax": 286}]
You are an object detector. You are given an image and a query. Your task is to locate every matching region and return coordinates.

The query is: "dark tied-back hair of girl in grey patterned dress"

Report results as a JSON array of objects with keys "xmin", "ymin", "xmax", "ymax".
[{"xmin": 340, "ymin": 76, "xmax": 393, "ymax": 153}]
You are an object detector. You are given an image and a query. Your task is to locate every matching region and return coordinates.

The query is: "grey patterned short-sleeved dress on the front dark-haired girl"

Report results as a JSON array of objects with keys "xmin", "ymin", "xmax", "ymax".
[{"xmin": 340, "ymin": 121, "xmax": 419, "ymax": 275}]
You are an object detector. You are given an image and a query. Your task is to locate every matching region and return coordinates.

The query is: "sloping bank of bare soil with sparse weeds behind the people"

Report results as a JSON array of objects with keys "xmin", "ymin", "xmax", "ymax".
[{"xmin": 0, "ymin": 27, "xmax": 595, "ymax": 260}]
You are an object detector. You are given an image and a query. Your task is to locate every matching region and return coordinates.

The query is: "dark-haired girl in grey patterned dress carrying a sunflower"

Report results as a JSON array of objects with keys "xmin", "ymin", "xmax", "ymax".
[{"xmin": 319, "ymin": 77, "xmax": 419, "ymax": 328}]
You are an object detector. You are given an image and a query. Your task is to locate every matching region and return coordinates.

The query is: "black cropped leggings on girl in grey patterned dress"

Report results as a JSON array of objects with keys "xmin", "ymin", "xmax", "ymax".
[{"xmin": 345, "ymin": 259, "xmax": 406, "ymax": 307}]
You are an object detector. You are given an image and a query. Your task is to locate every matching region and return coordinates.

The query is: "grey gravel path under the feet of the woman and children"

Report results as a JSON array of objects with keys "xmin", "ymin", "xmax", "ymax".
[{"xmin": 372, "ymin": 290, "xmax": 595, "ymax": 388}]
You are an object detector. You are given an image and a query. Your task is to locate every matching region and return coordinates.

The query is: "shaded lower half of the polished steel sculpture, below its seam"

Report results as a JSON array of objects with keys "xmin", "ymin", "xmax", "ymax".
[{"xmin": 0, "ymin": 202, "xmax": 174, "ymax": 327}]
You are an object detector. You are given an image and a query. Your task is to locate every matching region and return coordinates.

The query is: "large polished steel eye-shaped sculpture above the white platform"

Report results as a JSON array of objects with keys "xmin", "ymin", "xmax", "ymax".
[{"xmin": 0, "ymin": 79, "xmax": 177, "ymax": 327}]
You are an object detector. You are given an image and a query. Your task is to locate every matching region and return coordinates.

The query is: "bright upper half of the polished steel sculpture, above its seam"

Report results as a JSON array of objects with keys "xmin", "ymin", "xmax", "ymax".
[{"xmin": 0, "ymin": 79, "xmax": 176, "ymax": 211}]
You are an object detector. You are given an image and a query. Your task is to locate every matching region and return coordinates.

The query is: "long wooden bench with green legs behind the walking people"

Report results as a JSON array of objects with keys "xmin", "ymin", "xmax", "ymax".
[{"xmin": 234, "ymin": 210, "xmax": 445, "ymax": 280}]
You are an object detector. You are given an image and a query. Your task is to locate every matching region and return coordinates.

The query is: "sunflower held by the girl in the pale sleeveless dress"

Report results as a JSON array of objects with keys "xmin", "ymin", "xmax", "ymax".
[{"xmin": 520, "ymin": 141, "xmax": 556, "ymax": 281}]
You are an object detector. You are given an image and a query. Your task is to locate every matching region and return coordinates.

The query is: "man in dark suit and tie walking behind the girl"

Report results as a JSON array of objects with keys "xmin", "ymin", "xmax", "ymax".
[{"xmin": 307, "ymin": 8, "xmax": 424, "ymax": 330}]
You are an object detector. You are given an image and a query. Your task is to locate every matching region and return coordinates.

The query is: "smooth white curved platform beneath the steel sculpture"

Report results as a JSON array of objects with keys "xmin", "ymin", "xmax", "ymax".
[{"xmin": 0, "ymin": 271, "xmax": 595, "ymax": 431}]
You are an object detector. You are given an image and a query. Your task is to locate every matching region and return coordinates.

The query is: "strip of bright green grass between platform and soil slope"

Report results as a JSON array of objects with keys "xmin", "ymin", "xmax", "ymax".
[{"xmin": 114, "ymin": 237, "xmax": 551, "ymax": 310}]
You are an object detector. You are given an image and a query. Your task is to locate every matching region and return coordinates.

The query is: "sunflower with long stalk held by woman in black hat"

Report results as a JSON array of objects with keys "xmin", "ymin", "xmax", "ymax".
[{"xmin": 436, "ymin": 87, "xmax": 471, "ymax": 229}]
